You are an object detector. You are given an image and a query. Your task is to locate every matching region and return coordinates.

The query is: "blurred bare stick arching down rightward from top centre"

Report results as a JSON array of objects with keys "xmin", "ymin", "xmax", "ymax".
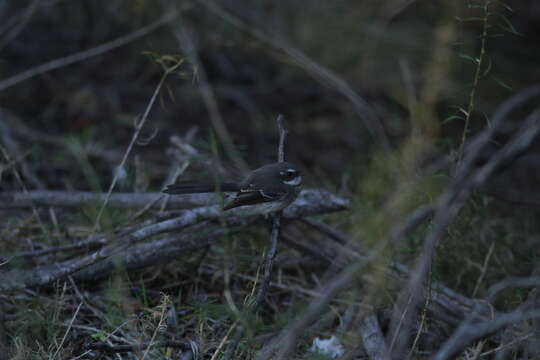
[{"xmin": 199, "ymin": 0, "xmax": 391, "ymax": 151}]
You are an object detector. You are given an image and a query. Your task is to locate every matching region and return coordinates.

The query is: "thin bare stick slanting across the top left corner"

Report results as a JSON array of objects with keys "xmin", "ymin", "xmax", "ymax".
[{"xmin": 0, "ymin": 10, "xmax": 179, "ymax": 91}]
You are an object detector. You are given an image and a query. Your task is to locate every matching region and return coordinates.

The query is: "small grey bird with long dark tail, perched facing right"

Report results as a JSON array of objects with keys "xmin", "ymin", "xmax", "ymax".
[{"xmin": 163, "ymin": 162, "xmax": 302, "ymax": 214}]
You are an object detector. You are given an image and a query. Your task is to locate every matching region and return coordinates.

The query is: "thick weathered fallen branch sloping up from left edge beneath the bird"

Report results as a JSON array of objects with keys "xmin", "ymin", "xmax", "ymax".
[{"xmin": 0, "ymin": 190, "xmax": 347, "ymax": 292}]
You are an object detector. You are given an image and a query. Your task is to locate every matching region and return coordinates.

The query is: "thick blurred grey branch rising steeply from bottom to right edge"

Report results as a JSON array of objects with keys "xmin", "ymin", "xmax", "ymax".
[{"xmin": 391, "ymin": 105, "xmax": 540, "ymax": 357}]
